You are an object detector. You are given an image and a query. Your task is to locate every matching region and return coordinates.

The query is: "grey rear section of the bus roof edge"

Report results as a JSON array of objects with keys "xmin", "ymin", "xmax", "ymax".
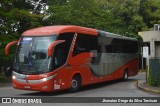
[{"xmin": 99, "ymin": 30, "xmax": 137, "ymax": 41}]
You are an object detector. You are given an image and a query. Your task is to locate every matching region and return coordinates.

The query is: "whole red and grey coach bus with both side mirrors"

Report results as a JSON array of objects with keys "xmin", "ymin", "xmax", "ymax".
[{"xmin": 5, "ymin": 25, "xmax": 139, "ymax": 92}]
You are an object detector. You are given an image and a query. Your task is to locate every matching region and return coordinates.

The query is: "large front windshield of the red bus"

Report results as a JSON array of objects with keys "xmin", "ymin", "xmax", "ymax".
[{"xmin": 13, "ymin": 36, "xmax": 57, "ymax": 74}]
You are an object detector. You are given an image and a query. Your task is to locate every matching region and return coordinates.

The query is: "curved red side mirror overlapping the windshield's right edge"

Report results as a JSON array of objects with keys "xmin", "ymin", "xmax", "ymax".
[{"xmin": 48, "ymin": 40, "xmax": 65, "ymax": 57}]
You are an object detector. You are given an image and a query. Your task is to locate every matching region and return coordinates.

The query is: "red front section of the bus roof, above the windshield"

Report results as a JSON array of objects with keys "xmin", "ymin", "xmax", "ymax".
[{"xmin": 22, "ymin": 25, "xmax": 98, "ymax": 36}]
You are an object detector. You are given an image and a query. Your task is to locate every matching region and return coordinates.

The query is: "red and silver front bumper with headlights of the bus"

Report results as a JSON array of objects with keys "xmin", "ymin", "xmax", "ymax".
[{"xmin": 12, "ymin": 72, "xmax": 68, "ymax": 92}]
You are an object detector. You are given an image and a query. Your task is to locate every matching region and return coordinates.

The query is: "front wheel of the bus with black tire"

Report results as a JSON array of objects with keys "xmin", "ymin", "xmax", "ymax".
[{"xmin": 69, "ymin": 76, "xmax": 81, "ymax": 93}]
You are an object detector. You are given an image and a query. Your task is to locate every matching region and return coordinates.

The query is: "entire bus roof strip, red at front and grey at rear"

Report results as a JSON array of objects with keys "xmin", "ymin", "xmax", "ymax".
[{"xmin": 22, "ymin": 25, "xmax": 137, "ymax": 41}]
